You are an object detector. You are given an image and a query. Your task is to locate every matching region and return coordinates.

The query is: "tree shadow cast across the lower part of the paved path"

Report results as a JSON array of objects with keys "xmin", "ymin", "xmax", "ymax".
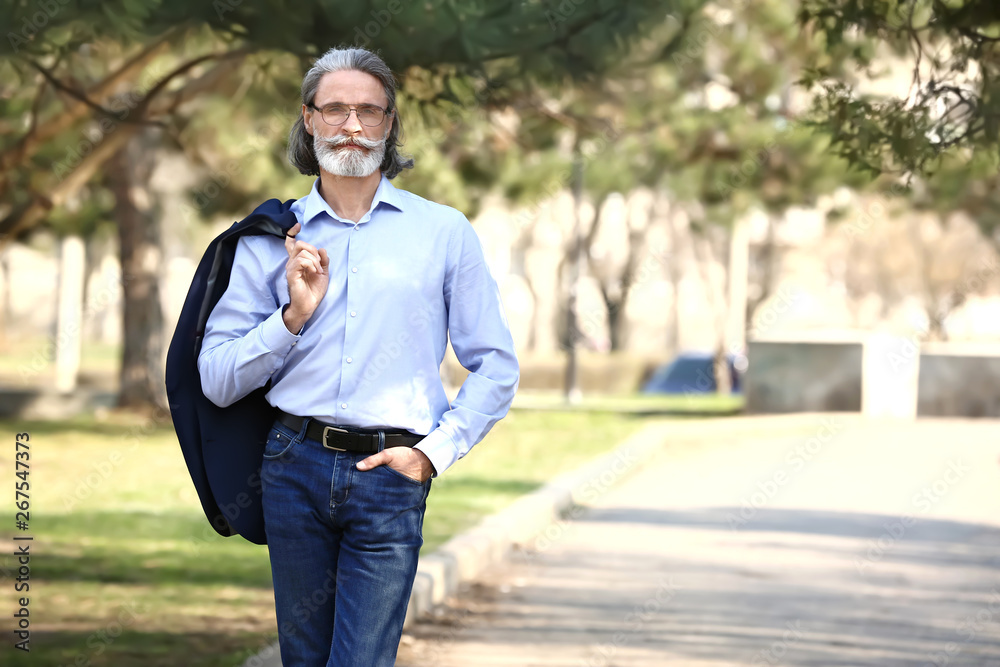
[{"xmin": 407, "ymin": 506, "xmax": 1000, "ymax": 667}]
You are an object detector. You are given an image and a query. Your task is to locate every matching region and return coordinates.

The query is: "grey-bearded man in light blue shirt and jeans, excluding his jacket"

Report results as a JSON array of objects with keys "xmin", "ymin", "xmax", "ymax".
[{"xmin": 198, "ymin": 49, "xmax": 518, "ymax": 667}]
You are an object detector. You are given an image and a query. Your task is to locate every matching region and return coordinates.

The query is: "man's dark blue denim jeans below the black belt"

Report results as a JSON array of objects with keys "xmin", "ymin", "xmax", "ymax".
[{"xmin": 261, "ymin": 420, "xmax": 431, "ymax": 667}]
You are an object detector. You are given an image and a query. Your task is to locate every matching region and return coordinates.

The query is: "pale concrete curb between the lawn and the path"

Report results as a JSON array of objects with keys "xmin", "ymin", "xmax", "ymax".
[{"xmin": 243, "ymin": 421, "xmax": 674, "ymax": 667}]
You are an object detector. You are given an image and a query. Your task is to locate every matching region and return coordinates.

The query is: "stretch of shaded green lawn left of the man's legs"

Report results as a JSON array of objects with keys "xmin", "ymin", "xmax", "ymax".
[{"xmin": 0, "ymin": 417, "xmax": 274, "ymax": 667}]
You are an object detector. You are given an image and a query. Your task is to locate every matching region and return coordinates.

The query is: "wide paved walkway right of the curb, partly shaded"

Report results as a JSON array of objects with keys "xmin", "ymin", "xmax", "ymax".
[{"xmin": 397, "ymin": 415, "xmax": 1000, "ymax": 667}]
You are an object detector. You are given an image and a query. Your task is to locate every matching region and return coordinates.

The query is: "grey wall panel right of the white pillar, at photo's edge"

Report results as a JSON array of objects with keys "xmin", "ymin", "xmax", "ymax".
[{"xmin": 917, "ymin": 349, "xmax": 1000, "ymax": 417}]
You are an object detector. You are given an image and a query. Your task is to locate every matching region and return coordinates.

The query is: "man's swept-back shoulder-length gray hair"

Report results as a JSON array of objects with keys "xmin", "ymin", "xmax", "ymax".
[{"xmin": 288, "ymin": 48, "xmax": 413, "ymax": 178}]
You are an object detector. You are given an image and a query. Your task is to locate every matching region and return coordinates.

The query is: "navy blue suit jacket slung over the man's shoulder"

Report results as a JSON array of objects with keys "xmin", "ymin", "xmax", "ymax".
[{"xmin": 166, "ymin": 199, "xmax": 297, "ymax": 544}]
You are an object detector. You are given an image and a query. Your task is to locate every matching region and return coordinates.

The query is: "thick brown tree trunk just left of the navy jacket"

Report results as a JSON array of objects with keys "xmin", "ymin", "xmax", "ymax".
[{"xmin": 106, "ymin": 133, "xmax": 166, "ymax": 412}]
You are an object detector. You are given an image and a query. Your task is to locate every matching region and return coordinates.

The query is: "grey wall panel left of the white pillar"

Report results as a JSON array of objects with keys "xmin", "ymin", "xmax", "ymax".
[{"xmin": 745, "ymin": 341, "xmax": 863, "ymax": 414}]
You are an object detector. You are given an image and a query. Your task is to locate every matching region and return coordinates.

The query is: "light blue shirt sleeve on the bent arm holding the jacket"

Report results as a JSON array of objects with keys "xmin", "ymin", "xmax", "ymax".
[{"xmin": 198, "ymin": 236, "xmax": 300, "ymax": 408}]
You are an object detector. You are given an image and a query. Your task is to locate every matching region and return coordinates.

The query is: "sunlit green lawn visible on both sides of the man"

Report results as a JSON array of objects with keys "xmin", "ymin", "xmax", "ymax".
[{"xmin": 0, "ymin": 411, "xmax": 642, "ymax": 667}]
